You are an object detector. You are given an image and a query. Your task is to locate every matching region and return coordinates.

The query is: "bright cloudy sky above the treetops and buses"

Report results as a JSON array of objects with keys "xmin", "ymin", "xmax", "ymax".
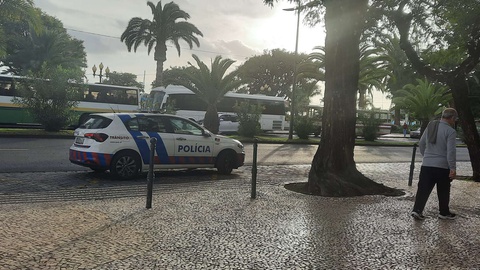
[{"xmin": 34, "ymin": 0, "xmax": 389, "ymax": 107}]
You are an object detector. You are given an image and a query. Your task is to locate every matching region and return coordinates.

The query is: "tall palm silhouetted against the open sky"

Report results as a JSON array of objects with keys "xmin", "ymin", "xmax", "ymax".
[{"xmin": 121, "ymin": 1, "xmax": 203, "ymax": 86}]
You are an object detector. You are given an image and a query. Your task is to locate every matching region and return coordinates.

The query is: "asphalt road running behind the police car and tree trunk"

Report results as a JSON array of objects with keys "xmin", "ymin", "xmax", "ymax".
[{"xmin": 0, "ymin": 138, "xmax": 470, "ymax": 173}]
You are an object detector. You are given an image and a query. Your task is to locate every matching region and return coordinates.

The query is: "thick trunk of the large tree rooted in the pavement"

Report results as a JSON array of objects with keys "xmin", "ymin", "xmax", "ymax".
[{"xmin": 308, "ymin": 0, "xmax": 400, "ymax": 196}]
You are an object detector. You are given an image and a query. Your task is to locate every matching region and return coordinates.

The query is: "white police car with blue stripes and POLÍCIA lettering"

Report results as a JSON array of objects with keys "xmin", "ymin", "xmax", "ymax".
[{"xmin": 69, "ymin": 113, "xmax": 245, "ymax": 179}]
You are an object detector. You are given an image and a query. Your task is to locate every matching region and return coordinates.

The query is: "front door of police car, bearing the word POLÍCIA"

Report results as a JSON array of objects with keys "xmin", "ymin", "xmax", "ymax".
[{"xmin": 168, "ymin": 117, "xmax": 214, "ymax": 165}]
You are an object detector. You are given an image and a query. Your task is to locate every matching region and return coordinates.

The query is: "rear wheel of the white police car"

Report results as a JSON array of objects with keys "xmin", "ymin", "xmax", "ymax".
[{"xmin": 110, "ymin": 152, "xmax": 140, "ymax": 180}]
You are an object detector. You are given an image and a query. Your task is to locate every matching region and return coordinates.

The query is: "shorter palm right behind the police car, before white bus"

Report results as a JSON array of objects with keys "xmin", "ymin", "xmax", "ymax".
[{"xmin": 169, "ymin": 54, "xmax": 242, "ymax": 134}]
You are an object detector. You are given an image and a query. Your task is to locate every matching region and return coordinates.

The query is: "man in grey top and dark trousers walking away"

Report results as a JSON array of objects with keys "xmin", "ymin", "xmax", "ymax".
[{"xmin": 411, "ymin": 108, "xmax": 458, "ymax": 220}]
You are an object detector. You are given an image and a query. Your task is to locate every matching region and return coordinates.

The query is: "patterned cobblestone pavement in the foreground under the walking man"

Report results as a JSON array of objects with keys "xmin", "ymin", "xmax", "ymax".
[{"xmin": 0, "ymin": 163, "xmax": 480, "ymax": 269}]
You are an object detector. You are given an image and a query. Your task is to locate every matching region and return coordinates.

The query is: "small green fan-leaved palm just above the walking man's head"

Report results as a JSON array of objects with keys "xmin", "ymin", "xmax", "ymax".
[{"xmin": 393, "ymin": 79, "xmax": 452, "ymax": 134}]
